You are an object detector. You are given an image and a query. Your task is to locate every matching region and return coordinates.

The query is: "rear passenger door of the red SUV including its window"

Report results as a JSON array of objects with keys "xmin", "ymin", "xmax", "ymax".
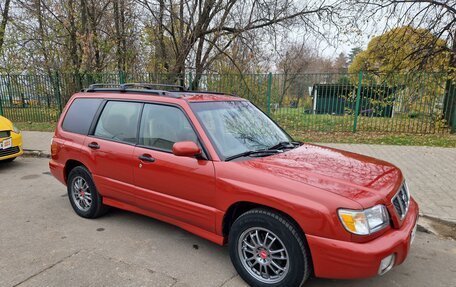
[{"xmin": 84, "ymin": 101, "xmax": 143, "ymax": 204}]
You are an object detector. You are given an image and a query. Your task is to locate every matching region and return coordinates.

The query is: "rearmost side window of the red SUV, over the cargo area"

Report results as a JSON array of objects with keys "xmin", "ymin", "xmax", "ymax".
[{"xmin": 62, "ymin": 98, "xmax": 102, "ymax": 135}]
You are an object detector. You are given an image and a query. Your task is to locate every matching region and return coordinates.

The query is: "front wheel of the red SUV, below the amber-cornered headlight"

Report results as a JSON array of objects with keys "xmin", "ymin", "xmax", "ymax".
[{"xmin": 228, "ymin": 209, "xmax": 312, "ymax": 287}]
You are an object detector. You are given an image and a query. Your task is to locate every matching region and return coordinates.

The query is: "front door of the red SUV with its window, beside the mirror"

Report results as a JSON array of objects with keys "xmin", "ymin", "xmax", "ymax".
[{"xmin": 133, "ymin": 104, "xmax": 216, "ymax": 232}]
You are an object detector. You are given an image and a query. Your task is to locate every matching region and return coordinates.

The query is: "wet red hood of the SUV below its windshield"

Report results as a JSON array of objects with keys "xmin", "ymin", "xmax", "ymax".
[{"xmin": 236, "ymin": 144, "xmax": 403, "ymax": 207}]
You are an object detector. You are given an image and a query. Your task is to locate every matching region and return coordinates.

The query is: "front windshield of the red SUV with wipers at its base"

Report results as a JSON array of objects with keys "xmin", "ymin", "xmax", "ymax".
[{"xmin": 191, "ymin": 101, "xmax": 291, "ymax": 159}]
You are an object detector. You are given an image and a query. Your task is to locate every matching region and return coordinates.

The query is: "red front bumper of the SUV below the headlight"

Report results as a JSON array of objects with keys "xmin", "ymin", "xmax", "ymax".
[{"xmin": 306, "ymin": 199, "xmax": 418, "ymax": 279}]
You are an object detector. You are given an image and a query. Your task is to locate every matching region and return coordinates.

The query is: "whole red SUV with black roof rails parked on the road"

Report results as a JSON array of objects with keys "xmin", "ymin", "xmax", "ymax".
[{"xmin": 49, "ymin": 84, "xmax": 418, "ymax": 286}]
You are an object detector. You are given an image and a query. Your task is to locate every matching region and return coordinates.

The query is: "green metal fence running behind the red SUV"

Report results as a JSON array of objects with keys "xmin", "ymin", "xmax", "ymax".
[{"xmin": 0, "ymin": 72, "xmax": 456, "ymax": 135}]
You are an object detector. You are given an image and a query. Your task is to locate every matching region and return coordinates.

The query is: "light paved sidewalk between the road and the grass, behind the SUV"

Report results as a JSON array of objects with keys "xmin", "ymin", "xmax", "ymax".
[{"xmin": 23, "ymin": 131, "xmax": 456, "ymax": 222}]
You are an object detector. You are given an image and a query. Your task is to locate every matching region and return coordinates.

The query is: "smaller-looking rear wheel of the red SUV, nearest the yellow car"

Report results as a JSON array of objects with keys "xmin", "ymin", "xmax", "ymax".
[{"xmin": 67, "ymin": 166, "xmax": 108, "ymax": 218}]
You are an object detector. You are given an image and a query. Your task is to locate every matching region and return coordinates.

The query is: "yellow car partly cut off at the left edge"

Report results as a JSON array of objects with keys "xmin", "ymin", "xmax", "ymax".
[{"xmin": 0, "ymin": 116, "xmax": 23, "ymax": 162}]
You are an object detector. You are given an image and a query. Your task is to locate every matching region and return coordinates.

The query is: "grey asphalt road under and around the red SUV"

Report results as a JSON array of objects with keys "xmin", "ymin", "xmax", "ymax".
[{"xmin": 0, "ymin": 158, "xmax": 456, "ymax": 287}]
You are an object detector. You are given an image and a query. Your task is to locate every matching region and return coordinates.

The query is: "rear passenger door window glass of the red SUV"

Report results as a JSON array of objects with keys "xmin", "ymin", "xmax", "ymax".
[{"xmin": 94, "ymin": 101, "xmax": 142, "ymax": 143}]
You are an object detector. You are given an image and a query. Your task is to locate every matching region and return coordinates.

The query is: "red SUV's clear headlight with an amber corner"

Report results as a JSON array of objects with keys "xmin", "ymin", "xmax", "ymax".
[{"xmin": 338, "ymin": 204, "xmax": 389, "ymax": 235}]
